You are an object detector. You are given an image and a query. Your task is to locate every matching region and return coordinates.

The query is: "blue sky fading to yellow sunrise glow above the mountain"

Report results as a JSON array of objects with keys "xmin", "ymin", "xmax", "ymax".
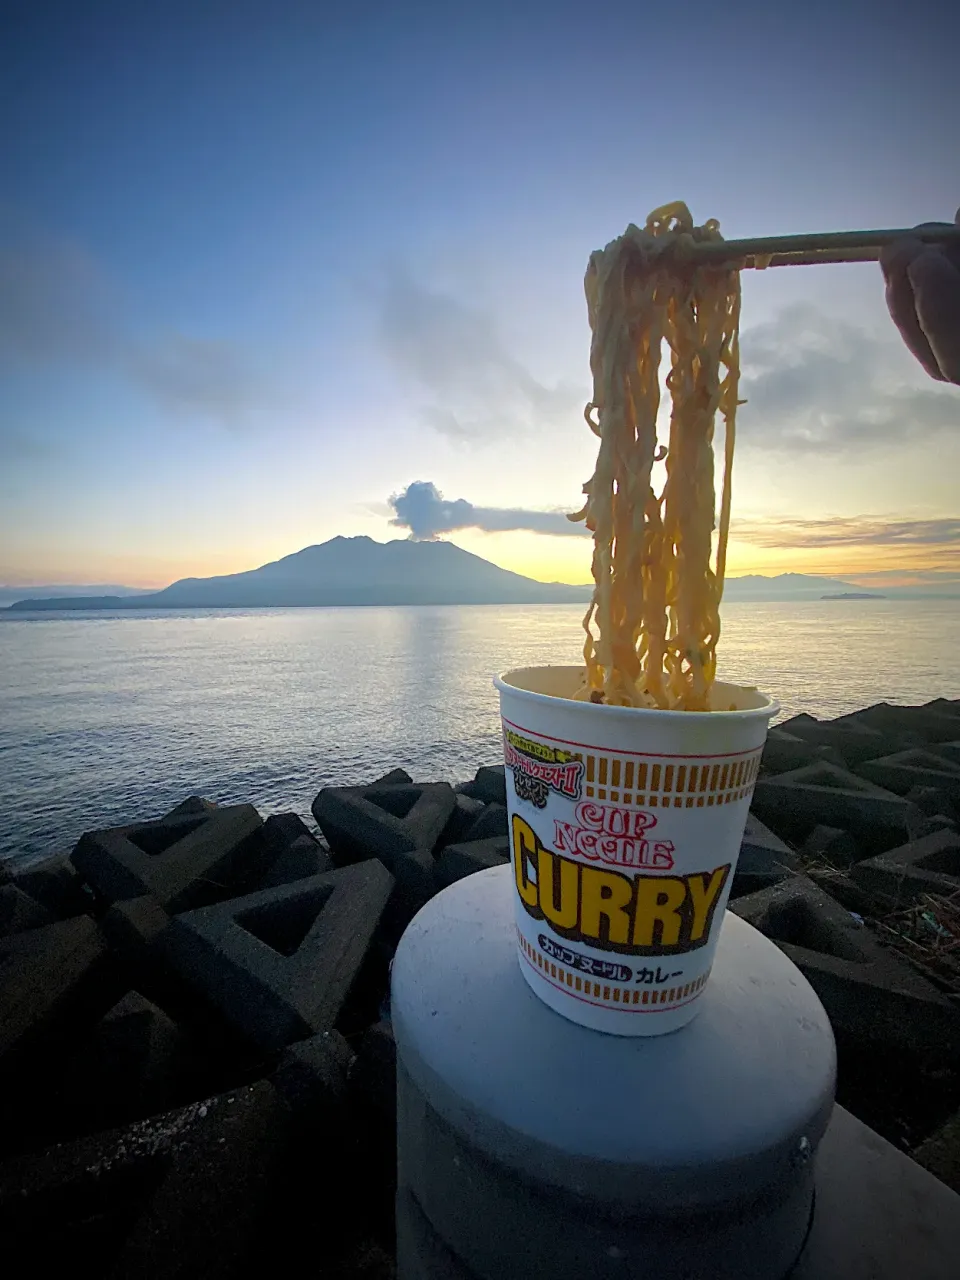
[{"xmin": 0, "ymin": 0, "xmax": 960, "ymax": 588}]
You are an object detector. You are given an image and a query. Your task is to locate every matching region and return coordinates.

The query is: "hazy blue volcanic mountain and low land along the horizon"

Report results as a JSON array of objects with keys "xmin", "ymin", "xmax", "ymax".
[{"xmin": 0, "ymin": 536, "xmax": 942, "ymax": 613}]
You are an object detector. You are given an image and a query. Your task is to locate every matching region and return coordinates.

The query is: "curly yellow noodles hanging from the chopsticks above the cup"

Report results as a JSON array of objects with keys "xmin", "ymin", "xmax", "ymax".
[{"xmin": 570, "ymin": 202, "xmax": 740, "ymax": 710}]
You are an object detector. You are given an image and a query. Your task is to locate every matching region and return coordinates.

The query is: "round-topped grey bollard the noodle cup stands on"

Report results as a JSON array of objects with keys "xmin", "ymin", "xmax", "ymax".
[{"xmin": 392, "ymin": 867, "xmax": 836, "ymax": 1280}]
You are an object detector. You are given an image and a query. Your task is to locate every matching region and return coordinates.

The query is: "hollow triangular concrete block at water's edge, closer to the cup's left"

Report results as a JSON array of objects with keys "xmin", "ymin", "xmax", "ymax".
[{"xmin": 312, "ymin": 782, "xmax": 456, "ymax": 878}]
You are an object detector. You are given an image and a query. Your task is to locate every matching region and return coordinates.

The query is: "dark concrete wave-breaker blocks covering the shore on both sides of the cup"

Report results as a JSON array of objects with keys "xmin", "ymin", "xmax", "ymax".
[{"xmin": 0, "ymin": 699, "xmax": 960, "ymax": 1280}]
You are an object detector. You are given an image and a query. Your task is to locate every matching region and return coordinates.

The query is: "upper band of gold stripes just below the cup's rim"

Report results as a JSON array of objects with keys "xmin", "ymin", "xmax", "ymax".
[{"xmin": 577, "ymin": 750, "xmax": 763, "ymax": 809}]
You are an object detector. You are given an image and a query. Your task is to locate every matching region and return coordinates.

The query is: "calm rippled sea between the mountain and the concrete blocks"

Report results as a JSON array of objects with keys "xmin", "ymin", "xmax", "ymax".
[{"xmin": 0, "ymin": 600, "xmax": 960, "ymax": 859}]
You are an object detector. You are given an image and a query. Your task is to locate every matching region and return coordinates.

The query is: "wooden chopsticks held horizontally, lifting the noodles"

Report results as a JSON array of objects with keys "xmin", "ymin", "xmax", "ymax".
[{"xmin": 675, "ymin": 227, "xmax": 960, "ymax": 269}]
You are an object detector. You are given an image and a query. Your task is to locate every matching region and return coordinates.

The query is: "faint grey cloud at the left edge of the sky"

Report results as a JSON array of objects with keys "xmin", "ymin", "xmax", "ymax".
[{"xmin": 0, "ymin": 227, "xmax": 266, "ymax": 426}]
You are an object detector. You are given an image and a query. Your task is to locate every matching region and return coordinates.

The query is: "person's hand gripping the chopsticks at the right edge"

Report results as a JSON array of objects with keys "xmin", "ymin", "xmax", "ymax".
[{"xmin": 879, "ymin": 209, "xmax": 960, "ymax": 385}]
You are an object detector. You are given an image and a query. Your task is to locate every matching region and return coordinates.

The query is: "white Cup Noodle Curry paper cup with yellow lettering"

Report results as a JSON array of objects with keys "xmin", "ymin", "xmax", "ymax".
[{"xmin": 494, "ymin": 667, "xmax": 778, "ymax": 1036}]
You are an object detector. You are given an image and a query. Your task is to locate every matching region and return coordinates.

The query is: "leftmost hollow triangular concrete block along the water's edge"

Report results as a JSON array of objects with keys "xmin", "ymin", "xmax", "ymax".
[{"xmin": 73, "ymin": 804, "xmax": 261, "ymax": 913}]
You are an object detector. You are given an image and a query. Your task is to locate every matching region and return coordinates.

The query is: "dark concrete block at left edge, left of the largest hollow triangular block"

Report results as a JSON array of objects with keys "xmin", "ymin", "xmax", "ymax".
[{"xmin": 0, "ymin": 915, "xmax": 113, "ymax": 1061}]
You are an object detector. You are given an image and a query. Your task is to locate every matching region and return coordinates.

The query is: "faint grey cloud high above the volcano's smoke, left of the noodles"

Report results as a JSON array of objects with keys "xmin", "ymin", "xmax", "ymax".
[{"xmin": 379, "ymin": 271, "xmax": 586, "ymax": 440}]
